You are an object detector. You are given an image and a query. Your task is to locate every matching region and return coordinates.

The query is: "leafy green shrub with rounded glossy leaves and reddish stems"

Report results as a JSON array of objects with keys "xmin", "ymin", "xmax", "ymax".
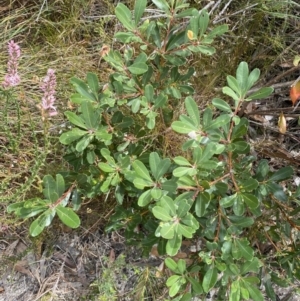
[{"xmin": 9, "ymin": 0, "xmax": 300, "ymax": 301}]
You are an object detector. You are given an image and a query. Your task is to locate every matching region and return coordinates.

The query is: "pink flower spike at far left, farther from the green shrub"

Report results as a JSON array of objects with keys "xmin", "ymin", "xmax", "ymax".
[{"xmin": 2, "ymin": 41, "xmax": 21, "ymax": 88}]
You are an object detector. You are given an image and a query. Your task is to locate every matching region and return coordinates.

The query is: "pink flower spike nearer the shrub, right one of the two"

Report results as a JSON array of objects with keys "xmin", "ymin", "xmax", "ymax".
[{"xmin": 41, "ymin": 69, "xmax": 57, "ymax": 116}]
